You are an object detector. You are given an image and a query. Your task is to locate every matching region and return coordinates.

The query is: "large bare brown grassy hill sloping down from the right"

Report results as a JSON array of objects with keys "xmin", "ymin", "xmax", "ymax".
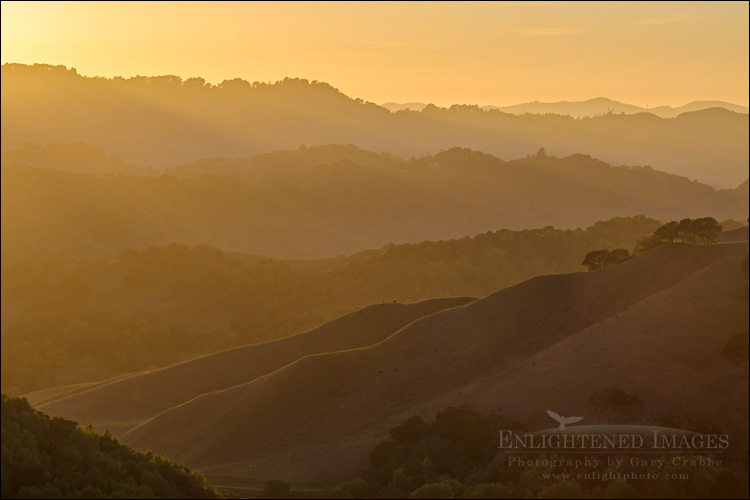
[{"xmin": 122, "ymin": 242, "xmax": 748, "ymax": 481}]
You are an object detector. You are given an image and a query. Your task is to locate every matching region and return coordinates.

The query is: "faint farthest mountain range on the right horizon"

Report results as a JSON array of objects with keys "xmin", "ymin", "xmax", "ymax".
[{"xmin": 381, "ymin": 97, "xmax": 748, "ymax": 118}]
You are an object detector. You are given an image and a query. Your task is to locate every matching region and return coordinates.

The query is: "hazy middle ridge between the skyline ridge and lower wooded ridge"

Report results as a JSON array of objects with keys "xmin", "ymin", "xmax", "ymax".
[{"xmin": 2, "ymin": 145, "xmax": 748, "ymax": 264}]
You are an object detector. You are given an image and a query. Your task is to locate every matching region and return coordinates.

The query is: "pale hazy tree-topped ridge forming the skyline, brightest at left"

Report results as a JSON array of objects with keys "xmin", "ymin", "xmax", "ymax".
[{"xmin": 2, "ymin": 64, "xmax": 748, "ymax": 187}]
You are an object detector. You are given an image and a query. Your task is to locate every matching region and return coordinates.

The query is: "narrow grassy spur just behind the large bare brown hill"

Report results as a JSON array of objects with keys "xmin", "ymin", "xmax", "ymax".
[{"xmin": 37, "ymin": 298, "xmax": 475, "ymax": 435}]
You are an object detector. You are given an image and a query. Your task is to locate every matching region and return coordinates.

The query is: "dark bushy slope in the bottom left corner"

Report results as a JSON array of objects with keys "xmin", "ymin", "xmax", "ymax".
[{"xmin": 2, "ymin": 394, "xmax": 216, "ymax": 498}]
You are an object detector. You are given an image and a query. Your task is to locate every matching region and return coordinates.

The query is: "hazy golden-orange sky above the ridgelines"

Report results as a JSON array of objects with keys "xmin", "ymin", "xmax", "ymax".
[{"xmin": 1, "ymin": 1, "xmax": 749, "ymax": 106}]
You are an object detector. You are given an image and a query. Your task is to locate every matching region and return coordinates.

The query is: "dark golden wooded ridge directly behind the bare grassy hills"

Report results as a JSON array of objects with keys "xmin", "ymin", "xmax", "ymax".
[{"xmin": 0, "ymin": 212, "xmax": 659, "ymax": 394}]
